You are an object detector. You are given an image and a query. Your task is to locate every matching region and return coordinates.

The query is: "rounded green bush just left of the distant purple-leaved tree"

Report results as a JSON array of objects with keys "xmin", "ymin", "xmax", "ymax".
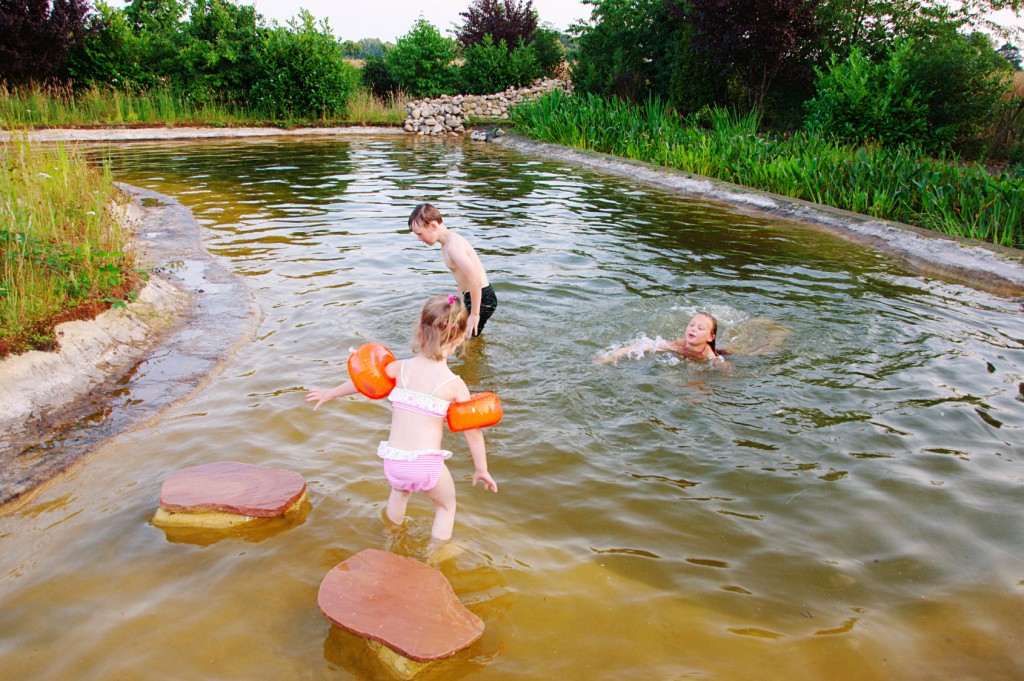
[{"xmin": 384, "ymin": 17, "xmax": 457, "ymax": 97}]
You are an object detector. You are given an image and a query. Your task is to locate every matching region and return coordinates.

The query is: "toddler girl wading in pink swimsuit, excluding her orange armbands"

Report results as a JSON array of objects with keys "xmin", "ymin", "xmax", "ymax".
[{"xmin": 305, "ymin": 295, "xmax": 498, "ymax": 541}]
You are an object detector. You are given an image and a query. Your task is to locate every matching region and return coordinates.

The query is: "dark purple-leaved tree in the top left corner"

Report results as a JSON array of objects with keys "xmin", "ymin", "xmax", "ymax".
[{"xmin": 0, "ymin": 0, "xmax": 90, "ymax": 85}]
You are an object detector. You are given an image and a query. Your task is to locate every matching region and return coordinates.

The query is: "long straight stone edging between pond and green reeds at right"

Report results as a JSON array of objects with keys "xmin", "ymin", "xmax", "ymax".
[{"xmin": 487, "ymin": 134, "xmax": 1024, "ymax": 297}]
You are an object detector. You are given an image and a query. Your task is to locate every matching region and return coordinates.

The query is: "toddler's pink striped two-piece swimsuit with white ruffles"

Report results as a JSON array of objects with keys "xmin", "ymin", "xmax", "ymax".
[{"xmin": 377, "ymin": 361, "xmax": 456, "ymax": 492}]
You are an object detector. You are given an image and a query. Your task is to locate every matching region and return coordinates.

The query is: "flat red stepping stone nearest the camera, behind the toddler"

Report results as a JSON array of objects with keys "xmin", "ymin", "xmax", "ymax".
[{"xmin": 316, "ymin": 549, "xmax": 483, "ymax": 663}]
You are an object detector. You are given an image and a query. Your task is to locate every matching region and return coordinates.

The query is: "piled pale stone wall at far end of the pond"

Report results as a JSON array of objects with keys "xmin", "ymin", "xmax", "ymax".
[{"xmin": 404, "ymin": 78, "xmax": 572, "ymax": 136}]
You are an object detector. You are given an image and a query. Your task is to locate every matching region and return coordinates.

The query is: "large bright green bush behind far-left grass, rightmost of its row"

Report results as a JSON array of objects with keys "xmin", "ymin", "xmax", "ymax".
[{"xmin": 250, "ymin": 10, "xmax": 358, "ymax": 119}]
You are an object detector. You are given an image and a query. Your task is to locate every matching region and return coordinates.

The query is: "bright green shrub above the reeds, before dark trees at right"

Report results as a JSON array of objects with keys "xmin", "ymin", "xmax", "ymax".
[{"xmin": 806, "ymin": 40, "xmax": 941, "ymax": 147}]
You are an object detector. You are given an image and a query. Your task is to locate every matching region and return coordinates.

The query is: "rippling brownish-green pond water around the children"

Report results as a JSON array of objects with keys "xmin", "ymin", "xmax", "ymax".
[{"xmin": 0, "ymin": 136, "xmax": 1024, "ymax": 681}]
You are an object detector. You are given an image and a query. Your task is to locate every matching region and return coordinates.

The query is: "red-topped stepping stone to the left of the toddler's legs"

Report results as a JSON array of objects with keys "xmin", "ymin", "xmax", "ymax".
[{"xmin": 153, "ymin": 461, "xmax": 306, "ymax": 528}]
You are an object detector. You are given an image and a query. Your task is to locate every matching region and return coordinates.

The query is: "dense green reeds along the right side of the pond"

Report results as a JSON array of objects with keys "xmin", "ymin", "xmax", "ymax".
[{"xmin": 512, "ymin": 92, "xmax": 1024, "ymax": 248}]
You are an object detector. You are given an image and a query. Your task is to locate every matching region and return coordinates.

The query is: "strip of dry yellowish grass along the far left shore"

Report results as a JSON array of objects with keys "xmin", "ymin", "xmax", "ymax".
[{"xmin": 0, "ymin": 85, "xmax": 406, "ymax": 130}]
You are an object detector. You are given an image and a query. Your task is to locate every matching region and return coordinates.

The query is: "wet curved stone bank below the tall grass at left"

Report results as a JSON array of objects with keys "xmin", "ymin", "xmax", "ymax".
[{"xmin": 0, "ymin": 183, "xmax": 259, "ymax": 507}]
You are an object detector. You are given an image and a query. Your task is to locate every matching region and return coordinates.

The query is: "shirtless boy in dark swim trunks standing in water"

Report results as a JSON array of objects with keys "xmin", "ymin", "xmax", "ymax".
[{"xmin": 409, "ymin": 204, "xmax": 498, "ymax": 338}]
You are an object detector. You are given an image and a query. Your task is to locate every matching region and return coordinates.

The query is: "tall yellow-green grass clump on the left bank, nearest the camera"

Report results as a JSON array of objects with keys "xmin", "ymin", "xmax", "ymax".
[{"xmin": 0, "ymin": 141, "xmax": 139, "ymax": 357}]
